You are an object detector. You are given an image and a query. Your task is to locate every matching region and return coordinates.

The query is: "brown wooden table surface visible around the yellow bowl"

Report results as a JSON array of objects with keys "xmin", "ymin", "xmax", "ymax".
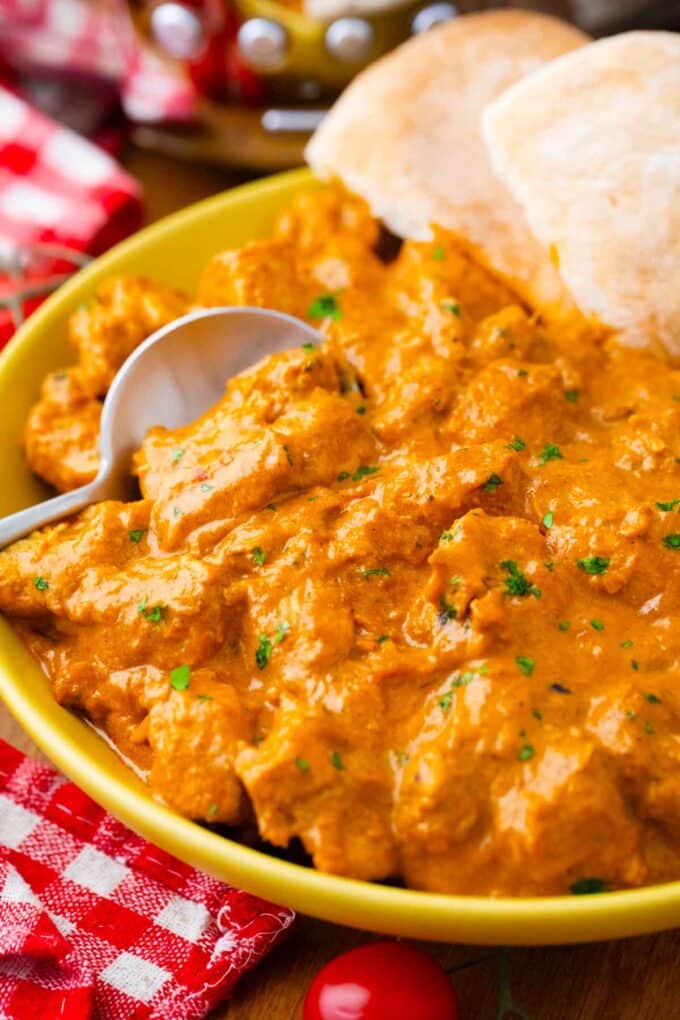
[{"xmin": 0, "ymin": 150, "xmax": 680, "ymax": 1020}]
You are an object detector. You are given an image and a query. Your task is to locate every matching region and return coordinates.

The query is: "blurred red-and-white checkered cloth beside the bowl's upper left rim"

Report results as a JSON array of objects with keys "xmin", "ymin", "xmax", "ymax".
[{"xmin": 0, "ymin": 81, "xmax": 142, "ymax": 348}]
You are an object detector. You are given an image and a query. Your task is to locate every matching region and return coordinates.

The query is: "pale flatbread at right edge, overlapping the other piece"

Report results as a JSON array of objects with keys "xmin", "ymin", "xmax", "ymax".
[{"xmin": 484, "ymin": 32, "xmax": 680, "ymax": 355}]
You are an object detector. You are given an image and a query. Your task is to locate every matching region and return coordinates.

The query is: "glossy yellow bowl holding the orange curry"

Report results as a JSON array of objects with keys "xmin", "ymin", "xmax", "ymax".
[{"xmin": 0, "ymin": 170, "xmax": 680, "ymax": 945}]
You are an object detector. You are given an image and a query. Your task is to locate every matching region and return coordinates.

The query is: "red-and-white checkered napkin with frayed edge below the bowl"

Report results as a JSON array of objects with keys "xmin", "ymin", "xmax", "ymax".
[{"xmin": 0, "ymin": 741, "xmax": 293, "ymax": 1020}]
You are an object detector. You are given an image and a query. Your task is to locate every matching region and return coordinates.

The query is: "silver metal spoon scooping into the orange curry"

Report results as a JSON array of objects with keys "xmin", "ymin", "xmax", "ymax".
[{"xmin": 0, "ymin": 308, "xmax": 321, "ymax": 549}]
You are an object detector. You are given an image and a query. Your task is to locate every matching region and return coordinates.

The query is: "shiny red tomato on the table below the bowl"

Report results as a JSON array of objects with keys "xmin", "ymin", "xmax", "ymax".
[{"xmin": 303, "ymin": 942, "xmax": 458, "ymax": 1020}]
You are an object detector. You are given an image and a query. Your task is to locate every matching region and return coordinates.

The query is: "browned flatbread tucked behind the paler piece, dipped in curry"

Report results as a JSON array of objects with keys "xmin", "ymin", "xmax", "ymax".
[{"xmin": 307, "ymin": 10, "xmax": 588, "ymax": 314}]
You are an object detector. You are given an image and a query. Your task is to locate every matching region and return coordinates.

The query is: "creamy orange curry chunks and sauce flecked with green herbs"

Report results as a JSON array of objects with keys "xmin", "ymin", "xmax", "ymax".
[{"xmin": 0, "ymin": 191, "xmax": 680, "ymax": 896}]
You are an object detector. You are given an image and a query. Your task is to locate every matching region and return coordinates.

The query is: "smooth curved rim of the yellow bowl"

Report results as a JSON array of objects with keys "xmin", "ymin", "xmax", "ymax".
[{"xmin": 0, "ymin": 169, "xmax": 680, "ymax": 945}]
